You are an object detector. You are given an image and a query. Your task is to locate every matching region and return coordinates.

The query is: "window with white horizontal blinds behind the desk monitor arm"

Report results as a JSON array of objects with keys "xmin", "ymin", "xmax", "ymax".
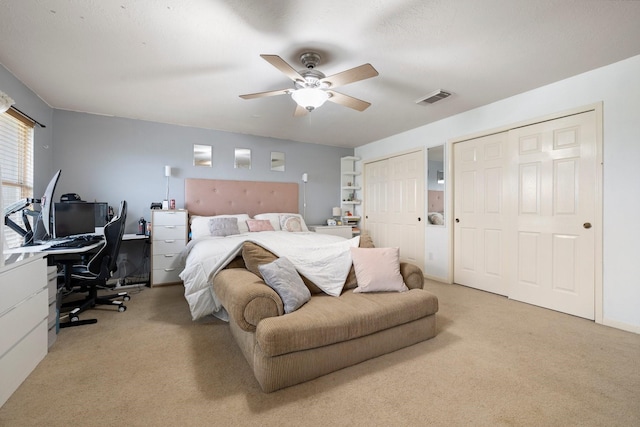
[{"xmin": 0, "ymin": 109, "xmax": 35, "ymax": 248}]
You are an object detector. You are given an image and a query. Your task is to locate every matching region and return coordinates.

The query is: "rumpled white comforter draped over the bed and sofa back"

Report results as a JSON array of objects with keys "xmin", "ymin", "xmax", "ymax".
[{"xmin": 180, "ymin": 231, "xmax": 360, "ymax": 320}]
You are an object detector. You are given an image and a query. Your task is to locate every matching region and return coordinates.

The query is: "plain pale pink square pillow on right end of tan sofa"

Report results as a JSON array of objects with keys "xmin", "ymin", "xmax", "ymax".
[{"xmin": 351, "ymin": 248, "xmax": 409, "ymax": 293}]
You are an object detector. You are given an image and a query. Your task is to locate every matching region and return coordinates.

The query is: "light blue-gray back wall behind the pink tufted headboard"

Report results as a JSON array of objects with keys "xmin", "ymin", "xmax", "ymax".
[{"xmin": 53, "ymin": 110, "xmax": 353, "ymax": 232}]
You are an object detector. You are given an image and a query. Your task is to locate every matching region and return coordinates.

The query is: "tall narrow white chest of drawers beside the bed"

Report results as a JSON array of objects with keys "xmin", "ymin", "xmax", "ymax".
[{"xmin": 151, "ymin": 210, "xmax": 189, "ymax": 286}]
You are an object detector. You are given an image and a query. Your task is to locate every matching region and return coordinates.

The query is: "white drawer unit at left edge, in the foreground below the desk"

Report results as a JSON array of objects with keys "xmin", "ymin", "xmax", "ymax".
[{"xmin": 0, "ymin": 253, "xmax": 49, "ymax": 406}]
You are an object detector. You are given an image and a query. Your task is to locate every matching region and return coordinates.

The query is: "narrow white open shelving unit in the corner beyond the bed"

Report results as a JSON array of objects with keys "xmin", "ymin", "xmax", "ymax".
[{"xmin": 340, "ymin": 156, "xmax": 362, "ymax": 235}]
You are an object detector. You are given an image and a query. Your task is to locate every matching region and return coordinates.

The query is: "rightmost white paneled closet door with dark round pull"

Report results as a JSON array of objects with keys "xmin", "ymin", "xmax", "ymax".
[{"xmin": 509, "ymin": 112, "xmax": 597, "ymax": 319}]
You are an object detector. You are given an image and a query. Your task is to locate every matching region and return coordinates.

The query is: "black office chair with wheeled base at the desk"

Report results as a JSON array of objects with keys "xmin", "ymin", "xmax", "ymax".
[{"xmin": 60, "ymin": 200, "xmax": 131, "ymax": 328}]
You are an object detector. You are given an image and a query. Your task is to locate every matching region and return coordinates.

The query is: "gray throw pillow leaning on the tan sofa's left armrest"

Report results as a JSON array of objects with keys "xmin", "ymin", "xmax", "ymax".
[{"xmin": 258, "ymin": 257, "xmax": 311, "ymax": 314}]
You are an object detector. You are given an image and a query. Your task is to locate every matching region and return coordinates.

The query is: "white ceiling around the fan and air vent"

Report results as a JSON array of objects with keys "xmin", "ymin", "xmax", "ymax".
[{"xmin": 0, "ymin": 0, "xmax": 640, "ymax": 147}]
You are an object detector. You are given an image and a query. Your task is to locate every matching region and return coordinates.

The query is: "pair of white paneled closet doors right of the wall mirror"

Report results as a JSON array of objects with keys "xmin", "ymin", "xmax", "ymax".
[{"xmin": 454, "ymin": 111, "xmax": 597, "ymax": 319}]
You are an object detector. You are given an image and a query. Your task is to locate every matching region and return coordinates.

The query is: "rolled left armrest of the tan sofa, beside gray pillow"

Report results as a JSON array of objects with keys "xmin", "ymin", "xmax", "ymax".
[{"xmin": 213, "ymin": 268, "xmax": 284, "ymax": 332}]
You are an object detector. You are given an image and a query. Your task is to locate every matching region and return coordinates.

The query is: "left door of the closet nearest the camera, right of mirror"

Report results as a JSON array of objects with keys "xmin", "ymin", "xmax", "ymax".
[{"xmin": 453, "ymin": 132, "xmax": 510, "ymax": 295}]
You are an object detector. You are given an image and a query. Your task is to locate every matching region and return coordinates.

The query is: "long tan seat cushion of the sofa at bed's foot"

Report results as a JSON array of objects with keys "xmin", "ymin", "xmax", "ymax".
[{"xmin": 256, "ymin": 289, "xmax": 438, "ymax": 356}]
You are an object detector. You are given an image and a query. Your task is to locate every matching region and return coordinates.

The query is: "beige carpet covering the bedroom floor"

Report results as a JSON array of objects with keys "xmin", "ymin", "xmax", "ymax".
[{"xmin": 0, "ymin": 282, "xmax": 640, "ymax": 426}]
